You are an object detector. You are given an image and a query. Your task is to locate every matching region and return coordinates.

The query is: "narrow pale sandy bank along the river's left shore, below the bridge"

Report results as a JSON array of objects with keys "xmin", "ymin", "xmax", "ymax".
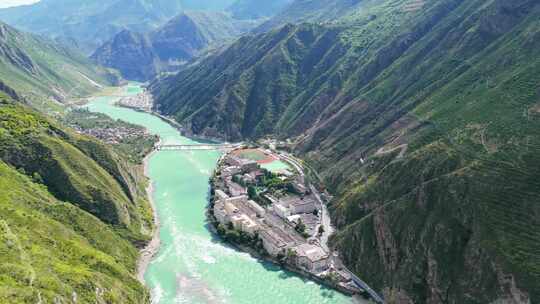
[{"xmin": 137, "ymin": 138, "xmax": 161, "ymax": 284}]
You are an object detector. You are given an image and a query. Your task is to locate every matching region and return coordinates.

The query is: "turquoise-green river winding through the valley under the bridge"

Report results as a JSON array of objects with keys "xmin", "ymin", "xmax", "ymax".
[{"xmin": 88, "ymin": 86, "xmax": 360, "ymax": 304}]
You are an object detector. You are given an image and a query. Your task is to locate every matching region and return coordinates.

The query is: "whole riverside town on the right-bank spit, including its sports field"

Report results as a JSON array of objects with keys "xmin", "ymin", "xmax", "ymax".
[{"xmin": 209, "ymin": 148, "xmax": 372, "ymax": 295}]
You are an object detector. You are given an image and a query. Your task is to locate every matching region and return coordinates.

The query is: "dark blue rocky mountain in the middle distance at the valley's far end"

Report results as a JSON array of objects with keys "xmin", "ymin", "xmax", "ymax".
[{"xmin": 91, "ymin": 11, "xmax": 256, "ymax": 81}]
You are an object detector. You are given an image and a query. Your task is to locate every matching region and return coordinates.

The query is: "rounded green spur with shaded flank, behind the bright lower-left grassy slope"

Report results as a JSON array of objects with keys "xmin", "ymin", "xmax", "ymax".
[{"xmin": 0, "ymin": 97, "xmax": 152, "ymax": 244}]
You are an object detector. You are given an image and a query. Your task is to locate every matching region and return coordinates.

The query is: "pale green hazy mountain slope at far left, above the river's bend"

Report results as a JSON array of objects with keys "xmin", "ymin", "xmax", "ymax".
[{"xmin": 0, "ymin": 22, "xmax": 114, "ymax": 102}]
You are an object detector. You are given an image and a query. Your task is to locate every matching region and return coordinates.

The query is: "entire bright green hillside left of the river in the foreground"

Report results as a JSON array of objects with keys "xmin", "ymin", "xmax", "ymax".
[{"xmin": 0, "ymin": 94, "xmax": 153, "ymax": 303}]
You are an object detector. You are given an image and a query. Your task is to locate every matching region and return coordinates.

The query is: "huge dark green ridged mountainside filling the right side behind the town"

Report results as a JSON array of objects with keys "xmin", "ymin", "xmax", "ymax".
[{"xmin": 154, "ymin": 0, "xmax": 540, "ymax": 303}]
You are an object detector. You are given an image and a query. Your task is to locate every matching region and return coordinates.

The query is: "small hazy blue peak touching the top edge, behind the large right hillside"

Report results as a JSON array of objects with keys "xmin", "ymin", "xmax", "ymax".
[{"xmin": 227, "ymin": 0, "xmax": 293, "ymax": 19}]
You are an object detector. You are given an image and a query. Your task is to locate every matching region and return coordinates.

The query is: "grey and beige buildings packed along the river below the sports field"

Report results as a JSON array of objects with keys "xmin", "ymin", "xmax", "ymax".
[{"xmin": 213, "ymin": 154, "xmax": 331, "ymax": 275}]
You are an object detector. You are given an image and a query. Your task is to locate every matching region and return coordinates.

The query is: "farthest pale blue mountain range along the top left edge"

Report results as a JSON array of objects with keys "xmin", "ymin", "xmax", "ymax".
[{"xmin": 0, "ymin": 0, "xmax": 233, "ymax": 53}]
